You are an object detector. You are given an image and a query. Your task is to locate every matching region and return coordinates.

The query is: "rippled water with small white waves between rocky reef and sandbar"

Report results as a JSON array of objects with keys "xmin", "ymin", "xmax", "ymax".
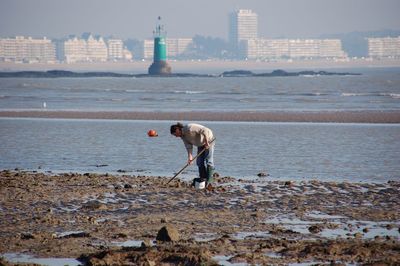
[{"xmin": 0, "ymin": 68, "xmax": 400, "ymax": 112}]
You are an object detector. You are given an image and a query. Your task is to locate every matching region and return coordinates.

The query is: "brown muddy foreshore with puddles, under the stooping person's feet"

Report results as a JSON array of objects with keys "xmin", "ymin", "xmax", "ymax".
[{"xmin": 0, "ymin": 171, "xmax": 400, "ymax": 265}]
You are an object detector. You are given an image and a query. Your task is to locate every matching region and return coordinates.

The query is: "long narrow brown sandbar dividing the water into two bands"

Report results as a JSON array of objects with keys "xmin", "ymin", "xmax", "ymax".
[{"xmin": 0, "ymin": 110, "xmax": 400, "ymax": 123}]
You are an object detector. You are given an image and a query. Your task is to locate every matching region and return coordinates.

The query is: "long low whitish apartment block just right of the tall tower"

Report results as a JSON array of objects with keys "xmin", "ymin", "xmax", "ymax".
[{"xmin": 241, "ymin": 38, "xmax": 346, "ymax": 60}]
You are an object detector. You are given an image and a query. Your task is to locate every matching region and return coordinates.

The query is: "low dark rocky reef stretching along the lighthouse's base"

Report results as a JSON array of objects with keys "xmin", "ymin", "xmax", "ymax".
[{"xmin": 0, "ymin": 69, "xmax": 361, "ymax": 78}]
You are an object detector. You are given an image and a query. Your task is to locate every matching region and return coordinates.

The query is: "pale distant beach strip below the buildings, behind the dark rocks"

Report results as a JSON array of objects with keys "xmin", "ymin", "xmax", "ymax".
[{"xmin": 0, "ymin": 58, "xmax": 400, "ymax": 75}]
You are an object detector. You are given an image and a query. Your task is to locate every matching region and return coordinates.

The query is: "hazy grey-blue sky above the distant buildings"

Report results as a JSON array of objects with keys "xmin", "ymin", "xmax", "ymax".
[{"xmin": 0, "ymin": 0, "xmax": 400, "ymax": 39}]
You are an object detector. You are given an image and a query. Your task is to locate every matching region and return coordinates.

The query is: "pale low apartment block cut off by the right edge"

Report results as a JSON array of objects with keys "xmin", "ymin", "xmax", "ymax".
[{"xmin": 368, "ymin": 36, "xmax": 400, "ymax": 58}]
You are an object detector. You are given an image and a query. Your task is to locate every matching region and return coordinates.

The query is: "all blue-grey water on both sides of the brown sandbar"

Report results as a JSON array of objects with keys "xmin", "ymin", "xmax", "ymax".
[{"xmin": 0, "ymin": 68, "xmax": 400, "ymax": 182}]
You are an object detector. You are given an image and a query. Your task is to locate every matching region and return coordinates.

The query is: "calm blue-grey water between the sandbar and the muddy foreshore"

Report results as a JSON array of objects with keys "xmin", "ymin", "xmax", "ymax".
[{"xmin": 0, "ymin": 118, "xmax": 400, "ymax": 182}]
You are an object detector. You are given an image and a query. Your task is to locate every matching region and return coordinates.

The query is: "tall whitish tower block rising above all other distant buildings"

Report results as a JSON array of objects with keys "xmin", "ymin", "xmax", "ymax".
[{"xmin": 229, "ymin": 9, "xmax": 258, "ymax": 52}]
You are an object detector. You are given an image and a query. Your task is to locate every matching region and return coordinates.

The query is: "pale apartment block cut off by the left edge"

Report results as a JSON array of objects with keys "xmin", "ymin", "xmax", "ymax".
[{"xmin": 0, "ymin": 36, "xmax": 56, "ymax": 63}]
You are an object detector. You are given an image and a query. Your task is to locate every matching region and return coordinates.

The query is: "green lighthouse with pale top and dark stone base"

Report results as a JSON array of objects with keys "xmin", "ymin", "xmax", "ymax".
[{"xmin": 149, "ymin": 17, "xmax": 171, "ymax": 75}]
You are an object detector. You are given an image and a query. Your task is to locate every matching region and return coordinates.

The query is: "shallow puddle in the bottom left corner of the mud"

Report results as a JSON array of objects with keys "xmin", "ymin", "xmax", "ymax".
[{"xmin": 2, "ymin": 253, "xmax": 83, "ymax": 266}]
